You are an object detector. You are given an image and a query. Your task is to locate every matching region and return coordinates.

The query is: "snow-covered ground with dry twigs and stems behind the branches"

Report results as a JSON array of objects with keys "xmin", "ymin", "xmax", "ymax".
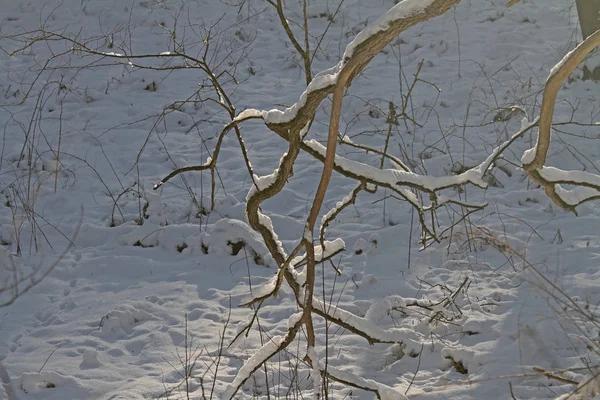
[{"xmin": 0, "ymin": 0, "xmax": 600, "ymax": 400}]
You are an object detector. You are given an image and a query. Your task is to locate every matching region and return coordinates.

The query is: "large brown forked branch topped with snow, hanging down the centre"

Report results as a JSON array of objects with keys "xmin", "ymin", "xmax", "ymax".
[{"xmin": 166, "ymin": 0, "xmax": 462, "ymax": 400}]
